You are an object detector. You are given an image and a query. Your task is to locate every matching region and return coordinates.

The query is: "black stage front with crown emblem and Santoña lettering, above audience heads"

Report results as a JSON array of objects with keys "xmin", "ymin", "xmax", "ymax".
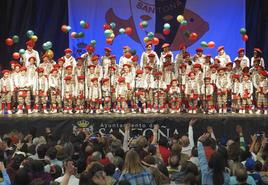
[{"xmin": 0, "ymin": 114, "xmax": 268, "ymax": 142}]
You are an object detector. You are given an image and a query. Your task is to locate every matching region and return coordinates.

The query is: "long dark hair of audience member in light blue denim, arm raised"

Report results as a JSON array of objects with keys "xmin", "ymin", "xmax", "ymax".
[{"xmin": 208, "ymin": 152, "xmax": 225, "ymax": 185}]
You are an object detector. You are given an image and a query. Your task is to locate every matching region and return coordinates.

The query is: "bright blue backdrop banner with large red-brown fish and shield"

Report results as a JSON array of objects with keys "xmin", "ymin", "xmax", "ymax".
[{"xmin": 69, "ymin": 0, "xmax": 245, "ymax": 59}]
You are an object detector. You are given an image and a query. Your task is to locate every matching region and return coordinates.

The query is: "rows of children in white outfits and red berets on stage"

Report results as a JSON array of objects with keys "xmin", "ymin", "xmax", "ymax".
[{"xmin": 0, "ymin": 41, "xmax": 268, "ymax": 114}]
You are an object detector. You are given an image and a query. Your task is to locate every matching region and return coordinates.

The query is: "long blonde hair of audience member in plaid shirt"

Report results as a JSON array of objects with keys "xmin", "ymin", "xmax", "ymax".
[{"xmin": 123, "ymin": 149, "xmax": 143, "ymax": 174}]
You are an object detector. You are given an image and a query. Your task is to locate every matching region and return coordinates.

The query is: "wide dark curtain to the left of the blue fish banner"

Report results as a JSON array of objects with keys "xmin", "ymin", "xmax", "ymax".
[{"xmin": 0, "ymin": 0, "xmax": 68, "ymax": 70}]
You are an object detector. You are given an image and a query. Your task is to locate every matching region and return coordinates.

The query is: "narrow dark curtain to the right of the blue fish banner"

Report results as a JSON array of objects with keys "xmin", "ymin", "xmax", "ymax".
[{"xmin": 246, "ymin": 0, "xmax": 268, "ymax": 69}]
